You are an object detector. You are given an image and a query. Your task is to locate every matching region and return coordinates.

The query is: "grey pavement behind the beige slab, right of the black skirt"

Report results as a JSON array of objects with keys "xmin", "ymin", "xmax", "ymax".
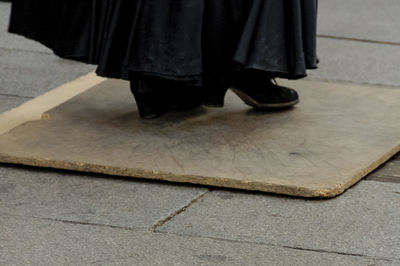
[{"xmin": 310, "ymin": 0, "xmax": 400, "ymax": 87}]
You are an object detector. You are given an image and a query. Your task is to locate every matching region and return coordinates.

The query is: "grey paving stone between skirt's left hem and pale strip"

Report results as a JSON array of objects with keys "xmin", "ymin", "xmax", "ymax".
[{"xmin": 0, "ymin": 48, "xmax": 94, "ymax": 97}]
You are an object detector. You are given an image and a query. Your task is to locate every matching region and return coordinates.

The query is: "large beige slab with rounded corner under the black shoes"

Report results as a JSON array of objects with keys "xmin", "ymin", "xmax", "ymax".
[{"xmin": 0, "ymin": 77, "xmax": 400, "ymax": 197}]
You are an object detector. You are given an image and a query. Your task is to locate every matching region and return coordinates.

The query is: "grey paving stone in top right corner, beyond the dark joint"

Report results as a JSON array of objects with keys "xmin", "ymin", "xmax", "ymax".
[{"xmin": 318, "ymin": 0, "xmax": 400, "ymax": 43}]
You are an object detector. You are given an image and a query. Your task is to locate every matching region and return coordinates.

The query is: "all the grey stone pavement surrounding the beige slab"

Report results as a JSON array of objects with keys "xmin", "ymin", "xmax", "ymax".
[{"xmin": 0, "ymin": 0, "xmax": 400, "ymax": 266}]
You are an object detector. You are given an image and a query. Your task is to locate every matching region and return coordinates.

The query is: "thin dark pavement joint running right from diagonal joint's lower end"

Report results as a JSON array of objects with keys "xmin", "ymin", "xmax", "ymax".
[{"xmin": 154, "ymin": 231, "xmax": 400, "ymax": 262}]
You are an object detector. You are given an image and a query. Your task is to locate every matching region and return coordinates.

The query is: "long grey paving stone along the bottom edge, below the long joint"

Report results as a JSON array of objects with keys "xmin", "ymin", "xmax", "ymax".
[{"xmin": 0, "ymin": 216, "xmax": 375, "ymax": 266}]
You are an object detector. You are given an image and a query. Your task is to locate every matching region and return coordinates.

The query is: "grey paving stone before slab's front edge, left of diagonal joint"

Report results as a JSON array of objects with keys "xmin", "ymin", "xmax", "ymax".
[{"xmin": 0, "ymin": 166, "xmax": 207, "ymax": 228}]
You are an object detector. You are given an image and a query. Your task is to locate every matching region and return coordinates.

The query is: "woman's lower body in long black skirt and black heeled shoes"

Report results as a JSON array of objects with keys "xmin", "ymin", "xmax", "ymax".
[{"xmin": 10, "ymin": 0, "xmax": 317, "ymax": 118}]
